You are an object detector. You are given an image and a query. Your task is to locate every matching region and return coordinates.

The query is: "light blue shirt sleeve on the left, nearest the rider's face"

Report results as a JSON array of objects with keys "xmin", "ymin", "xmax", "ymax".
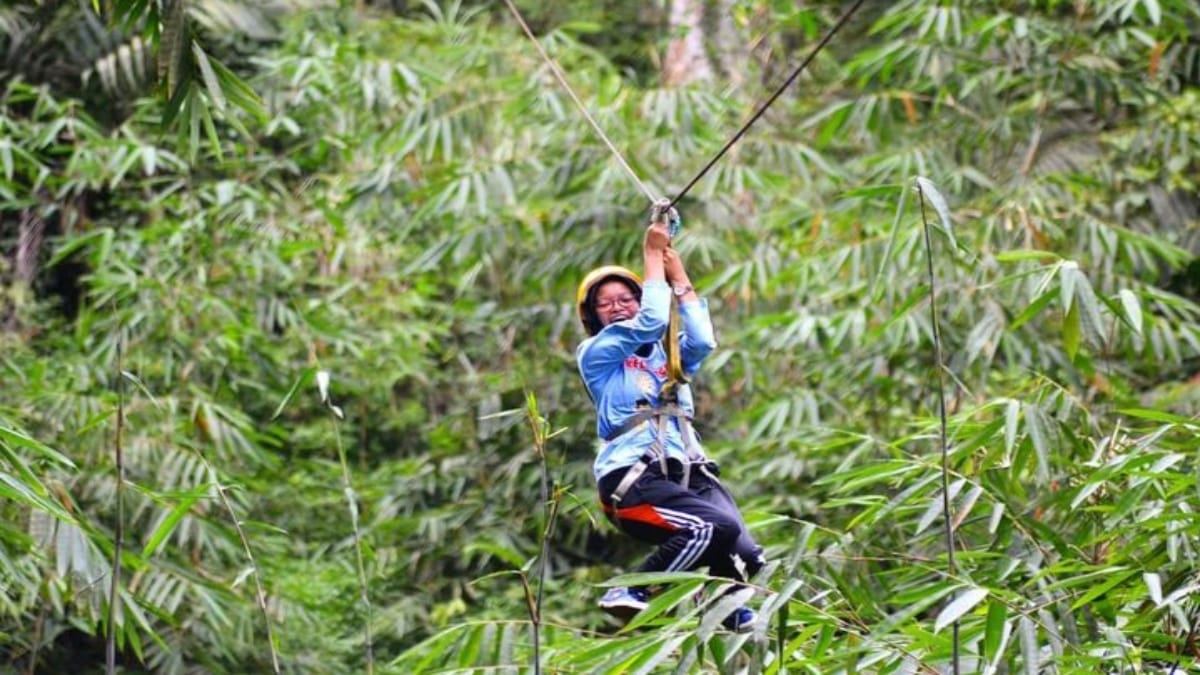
[{"xmin": 576, "ymin": 281, "xmax": 671, "ymax": 379}]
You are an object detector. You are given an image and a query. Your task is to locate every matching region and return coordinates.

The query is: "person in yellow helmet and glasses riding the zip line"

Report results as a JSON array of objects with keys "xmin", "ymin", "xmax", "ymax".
[{"xmin": 576, "ymin": 216, "xmax": 764, "ymax": 632}]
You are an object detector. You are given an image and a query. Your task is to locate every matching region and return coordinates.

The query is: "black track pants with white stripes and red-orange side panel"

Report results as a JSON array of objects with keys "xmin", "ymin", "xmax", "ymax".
[{"xmin": 599, "ymin": 460, "xmax": 764, "ymax": 581}]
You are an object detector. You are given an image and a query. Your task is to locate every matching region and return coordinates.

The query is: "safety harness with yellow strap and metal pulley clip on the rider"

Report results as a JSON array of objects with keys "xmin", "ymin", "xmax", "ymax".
[{"xmin": 605, "ymin": 199, "xmax": 716, "ymax": 508}]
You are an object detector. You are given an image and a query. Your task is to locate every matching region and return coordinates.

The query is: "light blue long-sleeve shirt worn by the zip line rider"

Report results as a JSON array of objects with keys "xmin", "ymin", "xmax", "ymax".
[{"xmin": 575, "ymin": 281, "xmax": 716, "ymax": 479}]
